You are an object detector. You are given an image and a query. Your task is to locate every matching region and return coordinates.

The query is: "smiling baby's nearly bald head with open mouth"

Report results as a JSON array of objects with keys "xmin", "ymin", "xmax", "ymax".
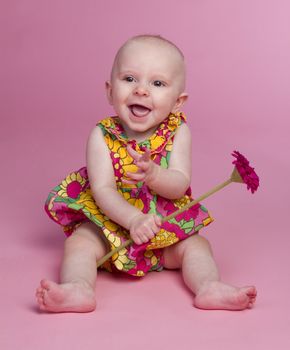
[{"xmin": 107, "ymin": 40, "xmax": 187, "ymax": 137}]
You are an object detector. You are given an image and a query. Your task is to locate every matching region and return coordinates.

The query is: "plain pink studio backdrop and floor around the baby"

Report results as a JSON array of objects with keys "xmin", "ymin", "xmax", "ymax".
[{"xmin": 0, "ymin": 0, "xmax": 290, "ymax": 350}]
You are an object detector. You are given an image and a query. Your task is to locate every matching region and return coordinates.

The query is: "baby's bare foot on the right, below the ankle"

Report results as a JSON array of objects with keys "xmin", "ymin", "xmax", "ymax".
[{"xmin": 194, "ymin": 281, "xmax": 257, "ymax": 310}]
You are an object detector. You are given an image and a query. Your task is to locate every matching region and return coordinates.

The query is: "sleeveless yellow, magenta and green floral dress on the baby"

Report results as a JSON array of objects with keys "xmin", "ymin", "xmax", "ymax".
[{"xmin": 45, "ymin": 112, "xmax": 213, "ymax": 276}]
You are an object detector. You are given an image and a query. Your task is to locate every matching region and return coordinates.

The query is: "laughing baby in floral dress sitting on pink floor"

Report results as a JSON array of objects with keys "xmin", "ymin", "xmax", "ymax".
[{"xmin": 36, "ymin": 35, "xmax": 256, "ymax": 312}]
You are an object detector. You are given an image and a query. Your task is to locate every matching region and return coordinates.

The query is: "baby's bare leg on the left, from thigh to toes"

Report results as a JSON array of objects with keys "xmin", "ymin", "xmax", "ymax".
[{"xmin": 36, "ymin": 223, "xmax": 108, "ymax": 312}]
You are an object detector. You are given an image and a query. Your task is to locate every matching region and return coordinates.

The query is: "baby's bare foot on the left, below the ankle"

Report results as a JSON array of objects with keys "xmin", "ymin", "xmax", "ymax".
[{"xmin": 36, "ymin": 280, "xmax": 96, "ymax": 312}]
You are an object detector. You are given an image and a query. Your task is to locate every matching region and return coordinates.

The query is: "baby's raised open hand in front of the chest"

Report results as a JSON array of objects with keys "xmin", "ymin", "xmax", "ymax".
[{"xmin": 122, "ymin": 145, "xmax": 157, "ymax": 185}]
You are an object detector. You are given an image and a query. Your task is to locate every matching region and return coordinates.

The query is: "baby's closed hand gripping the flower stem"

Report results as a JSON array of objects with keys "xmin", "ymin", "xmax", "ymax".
[{"xmin": 129, "ymin": 213, "xmax": 162, "ymax": 244}]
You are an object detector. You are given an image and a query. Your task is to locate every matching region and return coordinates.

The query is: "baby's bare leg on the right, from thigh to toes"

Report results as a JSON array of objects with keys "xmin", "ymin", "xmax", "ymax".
[{"xmin": 164, "ymin": 235, "xmax": 257, "ymax": 310}]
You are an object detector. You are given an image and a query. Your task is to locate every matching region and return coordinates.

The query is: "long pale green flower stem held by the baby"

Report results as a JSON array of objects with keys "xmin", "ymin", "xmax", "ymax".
[{"xmin": 97, "ymin": 178, "xmax": 233, "ymax": 267}]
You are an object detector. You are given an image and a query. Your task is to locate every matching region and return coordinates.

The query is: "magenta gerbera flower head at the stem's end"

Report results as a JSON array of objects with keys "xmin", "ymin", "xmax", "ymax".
[{"xmin": 231, "ymin": 151, "xmax": 259, "ymax": 193}]
